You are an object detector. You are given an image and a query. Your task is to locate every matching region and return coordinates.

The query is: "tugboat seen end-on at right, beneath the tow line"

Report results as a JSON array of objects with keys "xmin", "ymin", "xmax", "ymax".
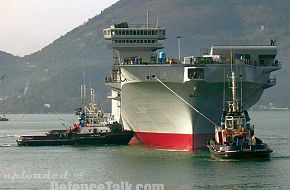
[{"xmin": 208, "ymin": 71, "xmax": 273, "ymax": 160}]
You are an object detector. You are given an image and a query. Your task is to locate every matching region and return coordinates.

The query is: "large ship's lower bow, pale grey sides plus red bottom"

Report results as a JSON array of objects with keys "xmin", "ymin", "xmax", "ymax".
[{"xmin": 121, "ymin": 75, "xmax": 263, "ymax": 151}]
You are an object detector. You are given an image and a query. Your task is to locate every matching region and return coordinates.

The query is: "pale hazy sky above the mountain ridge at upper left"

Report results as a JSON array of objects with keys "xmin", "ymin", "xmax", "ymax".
[{"xmin": 0, "ymin": 0, "xmax": 118, "ymax": 56}]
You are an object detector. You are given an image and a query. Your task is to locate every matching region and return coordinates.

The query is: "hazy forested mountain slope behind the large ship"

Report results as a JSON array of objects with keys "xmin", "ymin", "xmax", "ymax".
[{"xmin": 0, "ymin": 0, "xmax": 290, "ymax": 113}]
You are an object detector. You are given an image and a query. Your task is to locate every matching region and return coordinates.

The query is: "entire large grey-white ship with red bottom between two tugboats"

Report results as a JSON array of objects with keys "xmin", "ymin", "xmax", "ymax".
[{"xmin": 103, "ymin": 22, "xmax": 281, "ymax": 151}]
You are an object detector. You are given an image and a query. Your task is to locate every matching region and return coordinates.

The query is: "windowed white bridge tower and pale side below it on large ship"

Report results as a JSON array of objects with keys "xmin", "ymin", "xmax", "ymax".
[{"xmin": 104, "ymin": 22, "xmax": 165, "ymax": 123}]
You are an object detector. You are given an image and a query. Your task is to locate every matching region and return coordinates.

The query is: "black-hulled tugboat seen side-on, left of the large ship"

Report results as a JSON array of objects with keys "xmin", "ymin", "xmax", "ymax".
[{"xmin": 16, "ymin": 86, "xmax": 134, "ymax": 146}]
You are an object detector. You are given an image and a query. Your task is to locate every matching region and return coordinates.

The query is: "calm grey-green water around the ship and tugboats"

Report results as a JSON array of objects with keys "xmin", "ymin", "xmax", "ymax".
[{"xmin": 0, "ymin": 112, "xmax": 290, "ymax": 190}]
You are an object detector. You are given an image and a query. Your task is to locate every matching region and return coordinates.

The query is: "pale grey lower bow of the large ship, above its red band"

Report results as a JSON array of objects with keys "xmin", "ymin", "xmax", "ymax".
[{"xmin": 121, "ymin": 82, "xmax": 263, "ymax": 134}]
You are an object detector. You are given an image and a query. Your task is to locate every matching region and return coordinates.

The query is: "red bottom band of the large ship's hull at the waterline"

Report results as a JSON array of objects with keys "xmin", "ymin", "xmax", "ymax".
[{"xmin": 130, "ymin": 132, "xmax": 214, "ymax": 151}]
